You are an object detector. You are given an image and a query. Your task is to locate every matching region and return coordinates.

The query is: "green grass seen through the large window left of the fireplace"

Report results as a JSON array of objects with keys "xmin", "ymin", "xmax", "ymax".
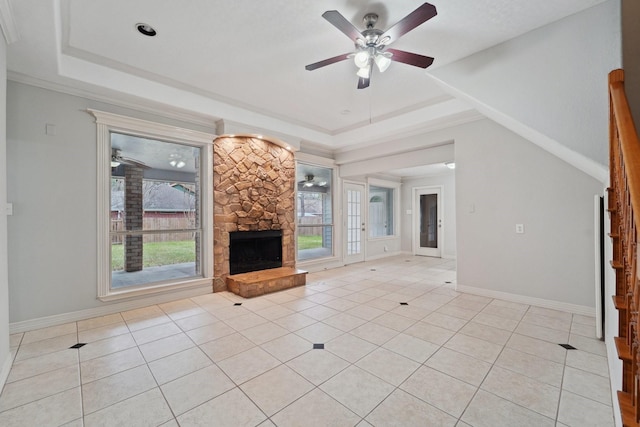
[{"xmin": 111, "ymin": 240, "xmax": 196, "ymax": 271}]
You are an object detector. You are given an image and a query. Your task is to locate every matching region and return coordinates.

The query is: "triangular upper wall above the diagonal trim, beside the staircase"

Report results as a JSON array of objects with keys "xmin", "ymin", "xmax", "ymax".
[{"xmin": 432, "ymin": 0, "xmax": 621, "ymax": 170}]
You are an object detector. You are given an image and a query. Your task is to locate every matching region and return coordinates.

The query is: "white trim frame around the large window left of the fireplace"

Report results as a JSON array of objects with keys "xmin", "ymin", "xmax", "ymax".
[{"xmin": 87, "ymin": 109, "xmax": 216, "ymax": 301}]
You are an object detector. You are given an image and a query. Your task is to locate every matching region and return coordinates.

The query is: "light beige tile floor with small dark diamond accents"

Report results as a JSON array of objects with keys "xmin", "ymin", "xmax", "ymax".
[{"xmin": 0, "ymin": 256, "xmax": 613, "ymax": 427}]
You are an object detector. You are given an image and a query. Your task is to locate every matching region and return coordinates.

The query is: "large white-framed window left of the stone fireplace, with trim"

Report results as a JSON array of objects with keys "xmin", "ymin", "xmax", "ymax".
[{"xmin": 91, "ymin": 111, "xmax": 214, "ymax": 300}]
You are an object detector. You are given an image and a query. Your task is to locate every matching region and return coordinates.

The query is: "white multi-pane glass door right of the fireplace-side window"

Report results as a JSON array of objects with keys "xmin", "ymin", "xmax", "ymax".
[{"xmin": 342, "ymin": 183, "xmax": 366, "ymax": 264}]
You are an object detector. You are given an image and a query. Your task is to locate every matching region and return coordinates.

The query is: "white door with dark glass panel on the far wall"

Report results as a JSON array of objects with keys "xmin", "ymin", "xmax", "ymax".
[{"xmin": 413, "ymin": 187, "xmax": 443, "ymax": 258}]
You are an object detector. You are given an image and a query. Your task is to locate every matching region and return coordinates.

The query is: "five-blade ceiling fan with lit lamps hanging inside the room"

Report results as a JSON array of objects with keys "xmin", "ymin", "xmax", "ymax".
[{"xmin": 305, "ymin": 3, "xmax": 437, "ymax": 89}]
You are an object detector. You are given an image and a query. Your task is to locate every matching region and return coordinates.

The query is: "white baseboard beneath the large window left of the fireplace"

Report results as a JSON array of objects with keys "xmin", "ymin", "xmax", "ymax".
[{"xmin": 9, "ymin": 283, "xmax": 212, "ymax": 334}]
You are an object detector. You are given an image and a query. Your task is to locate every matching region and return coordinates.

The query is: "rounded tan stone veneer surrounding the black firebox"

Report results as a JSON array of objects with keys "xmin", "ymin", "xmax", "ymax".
[{"xmin": 213, "ymin": 136, "xmax": 296, "ymax": 292}]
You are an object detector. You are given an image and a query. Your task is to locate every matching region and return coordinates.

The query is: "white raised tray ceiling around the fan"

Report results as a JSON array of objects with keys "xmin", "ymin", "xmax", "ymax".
[{"xmin": 3, "ymin": 0, "xmax": 603, "ymax": 154}]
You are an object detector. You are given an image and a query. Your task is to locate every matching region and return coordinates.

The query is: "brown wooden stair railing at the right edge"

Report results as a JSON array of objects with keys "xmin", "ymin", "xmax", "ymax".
[{"xmin": 607, "ymin": 70, "xmax": 640, "ymax": 427}]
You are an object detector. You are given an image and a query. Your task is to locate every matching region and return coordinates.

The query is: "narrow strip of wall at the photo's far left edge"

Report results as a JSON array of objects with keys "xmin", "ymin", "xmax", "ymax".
[{"xmin": 0, "ymin": 38, "xmax": 12, "ymax": 389}]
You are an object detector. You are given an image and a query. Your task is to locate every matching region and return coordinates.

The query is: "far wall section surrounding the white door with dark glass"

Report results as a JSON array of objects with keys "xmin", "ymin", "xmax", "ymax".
[{"xmin": 400, "ymin": 171, "xmax": 456, "ymax": 258}]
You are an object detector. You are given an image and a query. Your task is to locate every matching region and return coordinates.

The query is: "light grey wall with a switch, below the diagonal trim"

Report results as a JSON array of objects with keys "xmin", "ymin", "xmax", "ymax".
[{"xmin": 455, "ymin": 120, "xmax": 602, "ymax": 308}]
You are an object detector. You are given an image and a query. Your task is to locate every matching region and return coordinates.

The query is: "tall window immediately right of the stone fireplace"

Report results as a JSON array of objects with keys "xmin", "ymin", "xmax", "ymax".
[{"xmin": 296, "ymin": 162, "xmax": 334, "ymax": 261}]
